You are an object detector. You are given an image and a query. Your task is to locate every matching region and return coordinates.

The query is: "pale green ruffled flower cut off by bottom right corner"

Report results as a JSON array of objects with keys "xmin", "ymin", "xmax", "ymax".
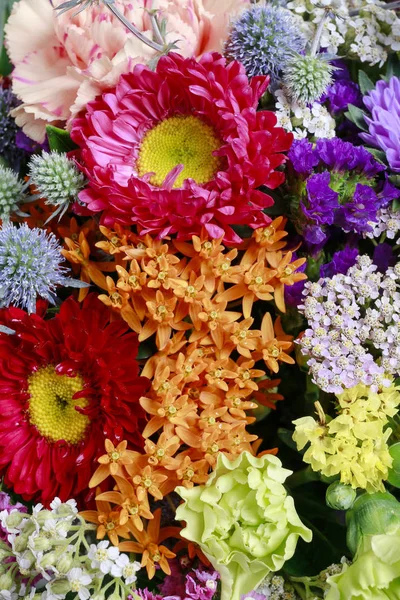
[{"xmin": 325, "ymin": 526, "xmax": 400, "ymax": 600}]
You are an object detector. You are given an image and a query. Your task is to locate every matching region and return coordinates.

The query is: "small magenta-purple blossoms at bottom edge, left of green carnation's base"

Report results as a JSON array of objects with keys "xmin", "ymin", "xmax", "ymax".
[{"xmin": 136, "ymin": 561, "xmax": 219, "ymax": 600}]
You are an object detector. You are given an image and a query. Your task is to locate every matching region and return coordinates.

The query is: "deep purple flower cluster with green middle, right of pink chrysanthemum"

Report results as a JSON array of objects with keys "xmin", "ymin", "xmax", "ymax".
[{"xmin": 289, "ymin": 138, "xmax": 400, "ymax": 248}]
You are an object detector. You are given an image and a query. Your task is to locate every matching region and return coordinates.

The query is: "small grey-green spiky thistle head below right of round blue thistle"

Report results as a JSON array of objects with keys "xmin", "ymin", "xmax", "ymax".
[{"xmin": 283, "ymin": 54, "xmax": 335, "ymax": 104}]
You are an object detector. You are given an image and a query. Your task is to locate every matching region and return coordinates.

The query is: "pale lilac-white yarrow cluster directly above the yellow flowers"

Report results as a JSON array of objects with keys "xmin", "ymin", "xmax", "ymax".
[{"xmin": 299, "ymin": 255, "xmax": 400, "ymax": 394}]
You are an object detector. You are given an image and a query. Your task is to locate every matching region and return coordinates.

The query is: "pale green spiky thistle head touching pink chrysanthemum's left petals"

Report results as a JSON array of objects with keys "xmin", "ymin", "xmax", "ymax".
[{"xmin": 29, "ymin": 152, "xmax": 85, "ymax": 218}]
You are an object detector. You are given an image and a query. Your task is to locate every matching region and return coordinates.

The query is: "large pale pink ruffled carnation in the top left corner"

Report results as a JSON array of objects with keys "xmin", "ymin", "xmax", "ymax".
[{"xmin": 5, "ymin": 0, "xmax": 249, "ymax": 142}]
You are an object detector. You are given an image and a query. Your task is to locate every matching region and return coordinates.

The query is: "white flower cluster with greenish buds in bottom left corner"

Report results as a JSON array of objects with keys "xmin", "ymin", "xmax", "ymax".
[{"xmin": 0, "ymin": 498, "xmax": 140, "ymax": 600}]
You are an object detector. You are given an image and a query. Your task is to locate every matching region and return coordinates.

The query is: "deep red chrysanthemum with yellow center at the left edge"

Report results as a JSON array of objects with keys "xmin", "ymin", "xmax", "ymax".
[{"xmin": 0, "ymin": 294, "xmax": 148, "ymax": 504}]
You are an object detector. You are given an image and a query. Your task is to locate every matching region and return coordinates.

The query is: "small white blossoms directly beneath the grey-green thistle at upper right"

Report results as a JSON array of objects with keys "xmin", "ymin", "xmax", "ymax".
[{"xmin": 275, "ymin": 90, "xmax": 336, "ymax": 140}]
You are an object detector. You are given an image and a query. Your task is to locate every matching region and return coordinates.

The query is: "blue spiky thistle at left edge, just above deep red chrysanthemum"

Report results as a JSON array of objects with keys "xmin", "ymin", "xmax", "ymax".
[{"xmin": 0, "ymin": 223, "xmax": 85, "ymax": 313}]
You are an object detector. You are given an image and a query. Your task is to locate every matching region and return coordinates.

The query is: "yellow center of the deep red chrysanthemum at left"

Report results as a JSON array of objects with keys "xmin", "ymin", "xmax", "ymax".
[{"xmin": 28, "ymin": 365, "xmax": 90, "ymax": 444}]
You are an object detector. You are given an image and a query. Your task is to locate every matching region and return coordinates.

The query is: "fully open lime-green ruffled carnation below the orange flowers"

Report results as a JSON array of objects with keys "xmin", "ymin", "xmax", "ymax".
[{"xmin": 176, "ymin": 452, "xmax": 312, "ymax": 600}]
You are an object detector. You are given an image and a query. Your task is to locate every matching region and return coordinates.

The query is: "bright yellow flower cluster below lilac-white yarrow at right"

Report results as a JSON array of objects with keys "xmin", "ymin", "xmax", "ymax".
[{"xmin": 293, "ymin": 384, "xmax": 400, "ymax": 493}]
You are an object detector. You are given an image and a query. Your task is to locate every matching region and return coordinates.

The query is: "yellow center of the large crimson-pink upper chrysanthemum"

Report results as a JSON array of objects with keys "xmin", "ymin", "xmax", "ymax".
[{"xmin": 136, "ymin": 115, "xmax": 221, "ymax": 188}]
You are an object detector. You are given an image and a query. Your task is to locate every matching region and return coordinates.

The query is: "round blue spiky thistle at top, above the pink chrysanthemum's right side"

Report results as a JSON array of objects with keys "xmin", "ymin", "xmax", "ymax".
[{"xmin": 225, "ymin": 5, "xmax": 306, "ymax": 81}]
